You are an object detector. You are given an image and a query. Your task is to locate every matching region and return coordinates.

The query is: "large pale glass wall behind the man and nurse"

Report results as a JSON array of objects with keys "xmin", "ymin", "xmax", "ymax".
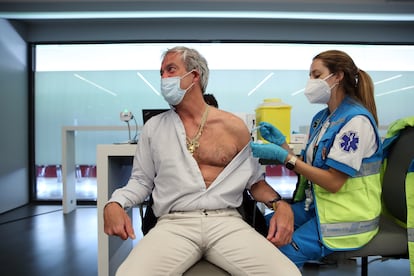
[{"xmin": 35, "ymin": 43, "xmax": 414, "ymax": 200}]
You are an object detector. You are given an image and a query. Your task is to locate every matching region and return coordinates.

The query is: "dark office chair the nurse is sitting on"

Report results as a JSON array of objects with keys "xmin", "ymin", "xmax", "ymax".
[{"xmin": 325, "ymin": 126, "xmax": 414, "ymax": 276}]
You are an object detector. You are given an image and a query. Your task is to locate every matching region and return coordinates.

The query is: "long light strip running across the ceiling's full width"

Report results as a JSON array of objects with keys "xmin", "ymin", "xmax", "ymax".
[{"xmin": 0, "ymin": 11, "xmax": 414, "ymax": 21}]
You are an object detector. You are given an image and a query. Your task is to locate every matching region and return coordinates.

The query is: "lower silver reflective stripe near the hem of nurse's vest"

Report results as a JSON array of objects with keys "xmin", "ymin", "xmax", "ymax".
[{"xmin": 321, "ymin": 217, "xmax": 379, "ymax": 237}]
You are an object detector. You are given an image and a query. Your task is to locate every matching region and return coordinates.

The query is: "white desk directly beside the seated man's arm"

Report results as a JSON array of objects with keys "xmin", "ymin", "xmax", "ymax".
[{"xmin": 96, "ymin": 144, "xmax": 136, "ymax": 276}]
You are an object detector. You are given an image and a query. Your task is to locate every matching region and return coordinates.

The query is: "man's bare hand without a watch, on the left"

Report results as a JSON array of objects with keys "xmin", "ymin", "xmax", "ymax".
[{"xmin": 104, "ymin": 202, "xmax": 135, "ymax": 240}]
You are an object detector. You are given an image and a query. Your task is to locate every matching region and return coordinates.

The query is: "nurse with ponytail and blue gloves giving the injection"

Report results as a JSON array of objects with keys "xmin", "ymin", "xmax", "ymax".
[{"xmin": 251, "ymin": 50, "xmax": 382, "ymax": 267}]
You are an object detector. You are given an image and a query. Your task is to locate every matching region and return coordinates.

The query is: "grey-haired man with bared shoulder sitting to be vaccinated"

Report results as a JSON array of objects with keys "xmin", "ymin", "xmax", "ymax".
[{"xmin": 104, "ymin": 47, "xmax": 300, "ymax": 275}]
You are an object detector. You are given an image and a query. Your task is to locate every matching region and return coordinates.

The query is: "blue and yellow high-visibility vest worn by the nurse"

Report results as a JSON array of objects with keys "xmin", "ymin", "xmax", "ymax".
[{"xmin": 294, "ymin": 98, "xmax": 382, "ymax": 250}]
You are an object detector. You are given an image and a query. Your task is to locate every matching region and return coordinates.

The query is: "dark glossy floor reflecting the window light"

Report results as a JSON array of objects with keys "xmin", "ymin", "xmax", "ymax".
[{"xmin": 0, "ymin": 205, "xmax": 410, "ymax": 276}]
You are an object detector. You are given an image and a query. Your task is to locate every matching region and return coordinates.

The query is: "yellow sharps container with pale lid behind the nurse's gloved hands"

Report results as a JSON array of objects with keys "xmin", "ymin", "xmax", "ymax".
[{"xmin": 256, "ymin": 98, "xmax": 292, "ymax": 143}]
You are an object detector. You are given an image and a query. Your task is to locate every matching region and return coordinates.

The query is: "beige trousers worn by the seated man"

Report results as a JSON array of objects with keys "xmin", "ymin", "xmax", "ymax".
[{"xmin": 117, "ymin": 209, "xmax": 300, "ymax": 276}]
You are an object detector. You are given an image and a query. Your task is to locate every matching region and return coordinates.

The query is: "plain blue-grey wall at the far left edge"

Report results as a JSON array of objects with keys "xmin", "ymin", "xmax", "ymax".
[{"xmin": 0, "ymin": 19, "xmax": 29, "ymax": 213}]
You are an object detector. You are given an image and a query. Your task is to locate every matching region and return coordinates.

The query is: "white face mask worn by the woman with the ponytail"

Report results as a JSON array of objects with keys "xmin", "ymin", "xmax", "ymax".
[{"xmin": 304, "ymin": 74, "xmax": 336, "ymax": 104}]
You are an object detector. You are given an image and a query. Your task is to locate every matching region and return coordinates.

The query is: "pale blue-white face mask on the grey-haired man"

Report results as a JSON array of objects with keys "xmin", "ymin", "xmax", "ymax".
[{"xmin": 161, "ymin": 70, "xmax": 194, "ymax": 105}]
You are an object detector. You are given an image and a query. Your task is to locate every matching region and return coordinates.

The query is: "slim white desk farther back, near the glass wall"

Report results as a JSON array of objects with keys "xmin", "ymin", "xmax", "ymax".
[{"xmin": 62, "ymin": 126, "xmax": 132, "ymax": 214}]
